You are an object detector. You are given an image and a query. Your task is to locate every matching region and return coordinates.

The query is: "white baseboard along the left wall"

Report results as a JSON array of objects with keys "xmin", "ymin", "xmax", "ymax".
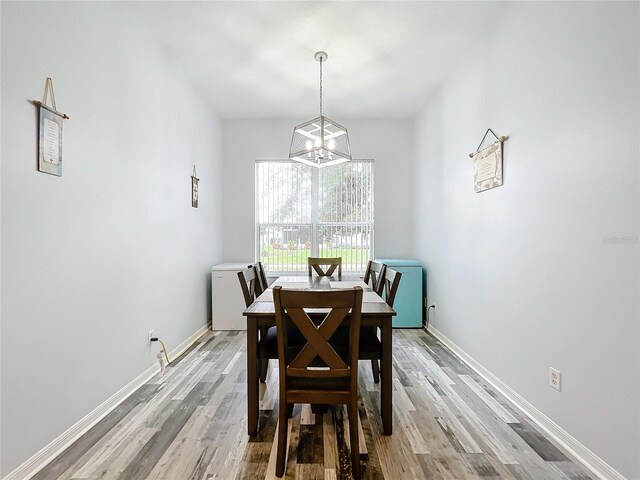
[{"xmin": 2, "ymin": 325, "xmax": 210, "ymax": 480}]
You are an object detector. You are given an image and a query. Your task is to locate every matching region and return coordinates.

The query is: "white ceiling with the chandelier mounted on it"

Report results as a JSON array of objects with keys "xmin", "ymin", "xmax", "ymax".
[{"xmin": 132, "ymin": 1, "xmax": 508, "ymax": 120}]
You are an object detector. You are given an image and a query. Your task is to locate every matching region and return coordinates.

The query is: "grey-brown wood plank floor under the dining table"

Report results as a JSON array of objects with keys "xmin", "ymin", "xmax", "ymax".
[{"xmin": 33, "ymin": 330, "xmax": 595, "ymax": 480}]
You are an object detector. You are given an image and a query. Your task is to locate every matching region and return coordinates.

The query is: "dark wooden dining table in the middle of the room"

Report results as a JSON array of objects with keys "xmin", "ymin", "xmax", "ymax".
[{"xmin": 243, "ymin": 275, "xmax": 396, "ymax": 435}]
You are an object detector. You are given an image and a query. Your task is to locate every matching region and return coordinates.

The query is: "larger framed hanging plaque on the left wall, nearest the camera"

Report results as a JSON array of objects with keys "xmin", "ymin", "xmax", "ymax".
[{"xmin": 33, "ymin": 77, "xmax": 69, "ymax": 177}]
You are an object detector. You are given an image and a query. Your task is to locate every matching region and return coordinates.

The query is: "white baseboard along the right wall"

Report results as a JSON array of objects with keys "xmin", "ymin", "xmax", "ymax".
[{"xmin": 429, "ymin": 325, "xmax": 626, "ymax": 480}]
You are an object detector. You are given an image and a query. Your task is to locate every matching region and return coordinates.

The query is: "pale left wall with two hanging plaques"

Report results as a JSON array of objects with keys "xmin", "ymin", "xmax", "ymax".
[{"xmin": 0, "ymin": 2, "xmax": 222, "ymax": 477}]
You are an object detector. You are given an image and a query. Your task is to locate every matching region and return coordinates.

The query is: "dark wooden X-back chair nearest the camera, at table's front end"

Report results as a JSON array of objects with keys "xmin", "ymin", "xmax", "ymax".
[{"xmin": 273, "ymin": 286, "xmax": 362, "ymax": 479}]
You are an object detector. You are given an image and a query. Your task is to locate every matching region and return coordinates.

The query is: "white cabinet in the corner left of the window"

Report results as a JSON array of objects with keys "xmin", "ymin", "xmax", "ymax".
[{"xmin": 211, "ymin": 262, "xmax": 253, "ymax": 330}]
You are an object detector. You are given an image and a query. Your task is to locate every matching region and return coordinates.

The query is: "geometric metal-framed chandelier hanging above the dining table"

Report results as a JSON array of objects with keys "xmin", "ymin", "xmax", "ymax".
[{"xmin": 289, "ymin": 52, "xmax": 351, "ymax": 168}]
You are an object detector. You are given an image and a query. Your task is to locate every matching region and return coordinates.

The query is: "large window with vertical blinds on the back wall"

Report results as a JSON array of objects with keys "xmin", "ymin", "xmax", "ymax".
[{"xmin": 256, "ymin": 160, "xmax": 373, "ymax": 273}]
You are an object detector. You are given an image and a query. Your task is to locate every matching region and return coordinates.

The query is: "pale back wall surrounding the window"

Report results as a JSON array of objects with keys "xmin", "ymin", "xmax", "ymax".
[{"xmin": 222, "ymin": 118, "xmax": 413, "ymax": 261}]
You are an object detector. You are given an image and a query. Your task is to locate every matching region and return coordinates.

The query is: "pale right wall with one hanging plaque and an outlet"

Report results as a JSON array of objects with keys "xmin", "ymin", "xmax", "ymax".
[{"xmin": 413, "ymin": 2, "xmax": 640, "ymax": 479}]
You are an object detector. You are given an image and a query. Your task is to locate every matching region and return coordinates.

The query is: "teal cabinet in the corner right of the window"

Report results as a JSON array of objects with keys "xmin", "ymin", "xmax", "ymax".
[{"xmin": 375, "ymin": 258, "xmax": 423, "ymax": 328}]
